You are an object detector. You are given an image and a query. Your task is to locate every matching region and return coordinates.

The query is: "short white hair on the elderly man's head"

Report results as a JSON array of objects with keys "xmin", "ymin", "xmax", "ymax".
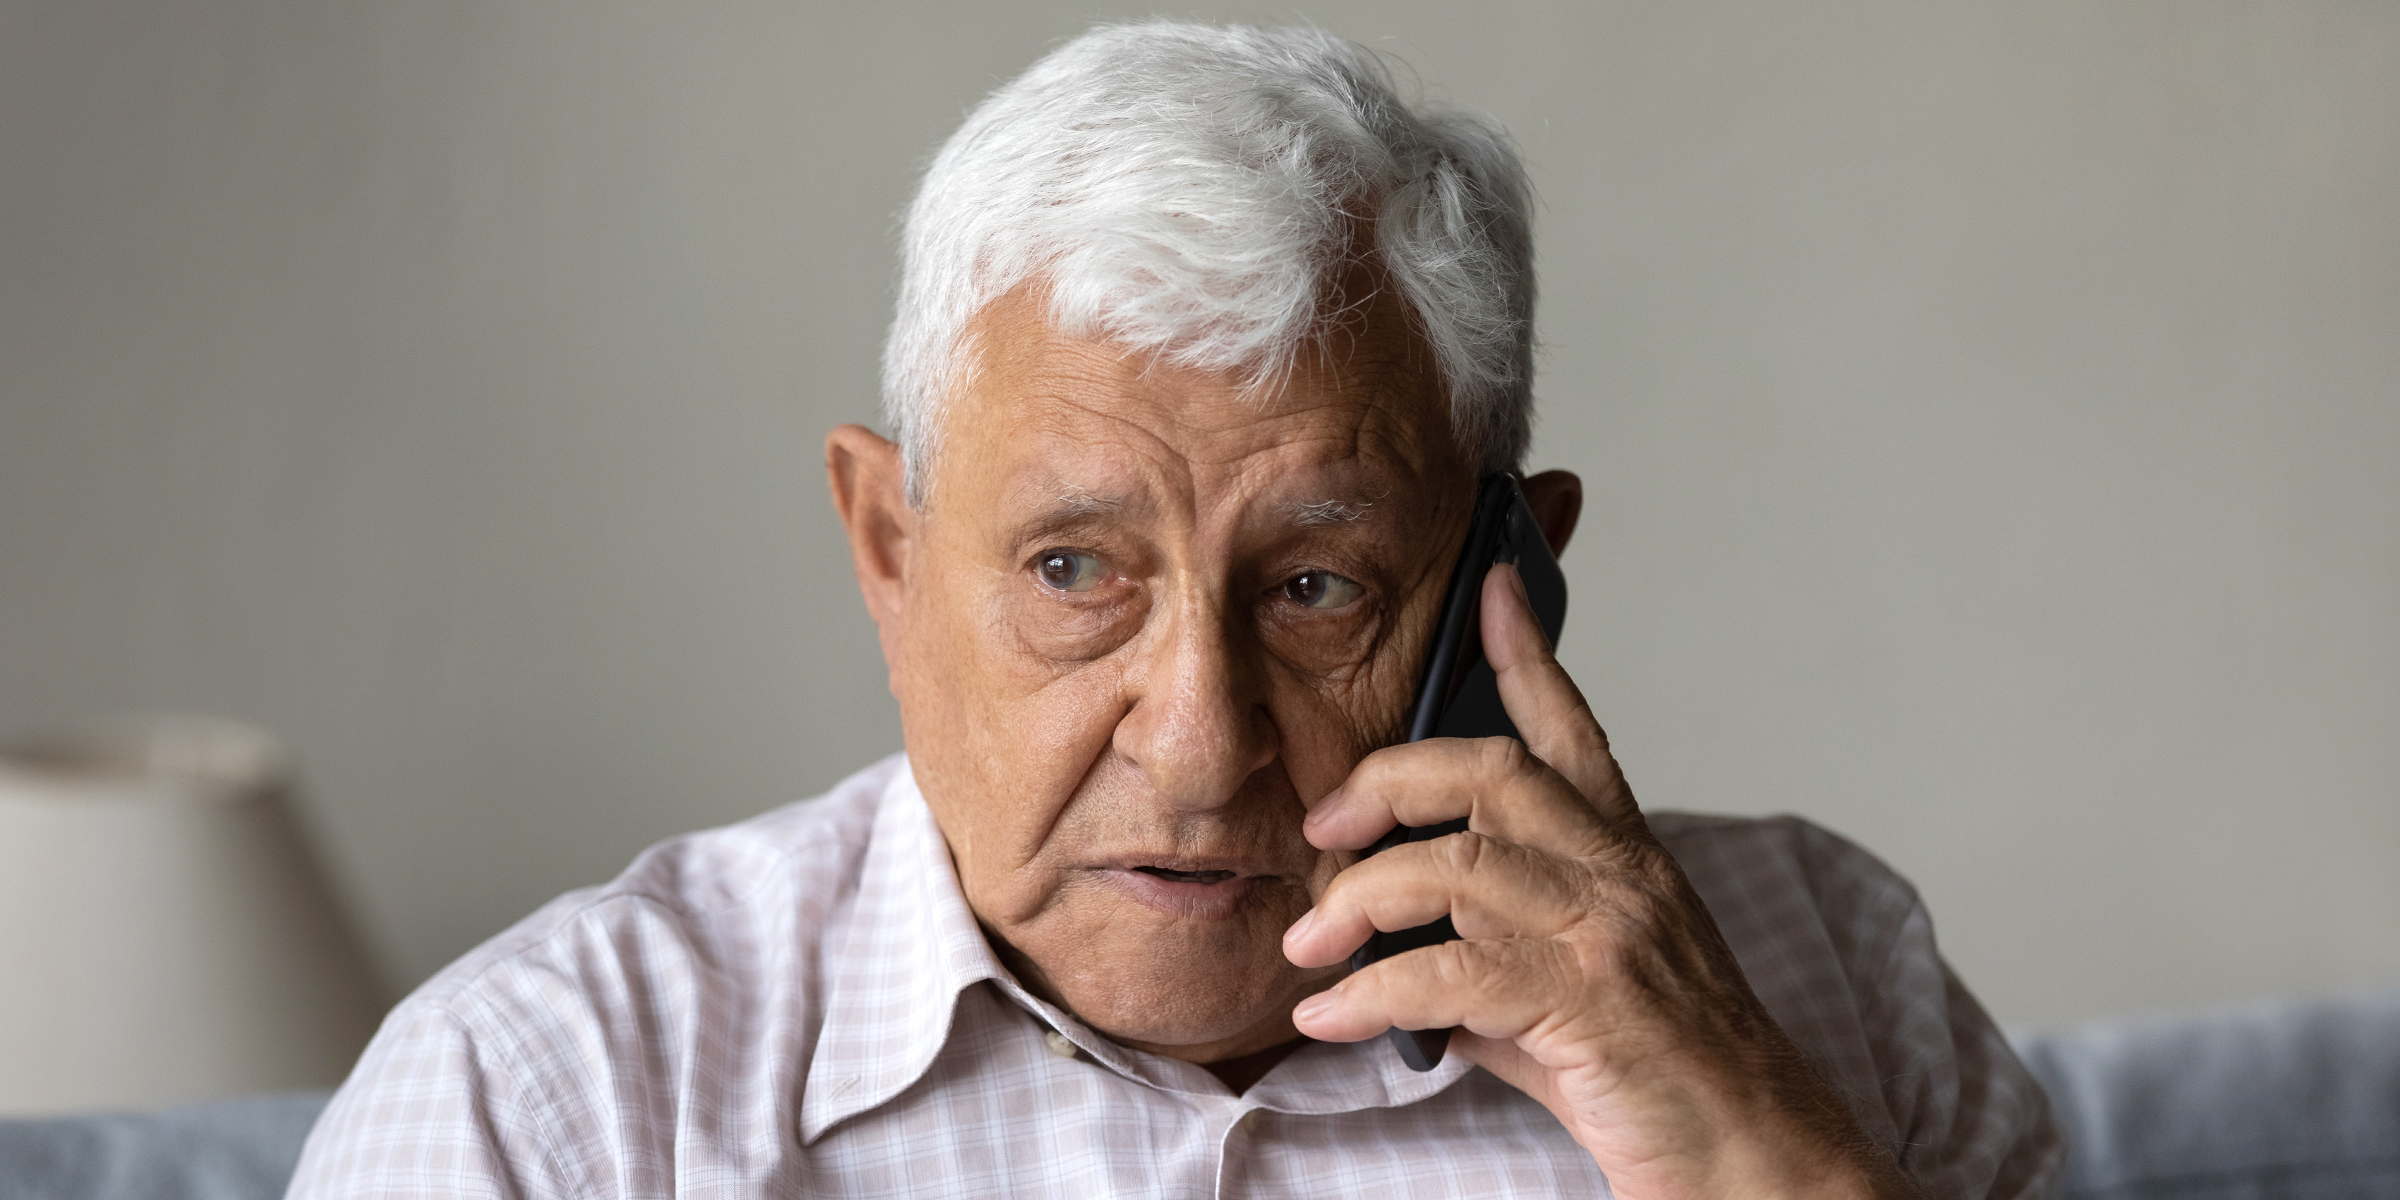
[{"xmin": 883, "ymin": 22, "xmax": 1534, "ymax": 504}]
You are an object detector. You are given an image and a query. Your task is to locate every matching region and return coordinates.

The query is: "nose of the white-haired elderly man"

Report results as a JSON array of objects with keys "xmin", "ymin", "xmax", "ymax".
[{"xmin": 1116, "ymin": 580, "xmax": 1279, "ymax": 811}]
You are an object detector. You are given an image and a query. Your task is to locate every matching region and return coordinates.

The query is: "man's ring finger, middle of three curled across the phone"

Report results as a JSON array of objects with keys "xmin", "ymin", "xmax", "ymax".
[{"xmin": 1284, "ymin": 833, "xmax": 1591, "ymax": 967}]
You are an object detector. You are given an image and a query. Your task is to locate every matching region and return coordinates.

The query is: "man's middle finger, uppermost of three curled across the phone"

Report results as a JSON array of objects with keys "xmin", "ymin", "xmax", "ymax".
[{"xmin": 1301, "ymin": 737, "xmax": 1608, "ymax": 854}]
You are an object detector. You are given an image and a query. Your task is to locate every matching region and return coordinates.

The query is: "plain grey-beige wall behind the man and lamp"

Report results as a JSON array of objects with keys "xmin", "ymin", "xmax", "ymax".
[{"xmin": 0, "ymin": 0, "xmax": 2400, "ymax": 1089}]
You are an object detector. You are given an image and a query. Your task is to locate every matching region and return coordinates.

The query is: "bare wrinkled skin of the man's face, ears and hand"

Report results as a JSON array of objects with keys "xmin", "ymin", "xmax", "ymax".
[{"xmin": 826, "ymin": 290, "xmax": 1913, "ymax": 1198}]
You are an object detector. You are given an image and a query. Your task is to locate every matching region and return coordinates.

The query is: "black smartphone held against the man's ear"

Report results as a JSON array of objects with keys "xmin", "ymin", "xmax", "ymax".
[{"xmin": 1351, "ymin": 473, "xmax": 1567, "ymax": 1070}]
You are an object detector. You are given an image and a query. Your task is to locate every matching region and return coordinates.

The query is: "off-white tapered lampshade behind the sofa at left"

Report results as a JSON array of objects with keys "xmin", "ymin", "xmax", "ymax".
[{"xmin": 0, "ymin": 718, "xmax": 382, "ymax": 1114}]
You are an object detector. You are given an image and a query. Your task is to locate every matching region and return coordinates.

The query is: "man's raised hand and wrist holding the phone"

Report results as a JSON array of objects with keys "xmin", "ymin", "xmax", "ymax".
[{"xmin": 1284, "ymin": 566, "xmax": 1915, "ymax": 1200}]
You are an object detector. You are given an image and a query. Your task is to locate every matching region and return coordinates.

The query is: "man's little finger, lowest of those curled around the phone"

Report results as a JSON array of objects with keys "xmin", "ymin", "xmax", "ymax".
[{"xmin": 1291, "ymin": 938, "xmax": 1577, "ymax": 1042}]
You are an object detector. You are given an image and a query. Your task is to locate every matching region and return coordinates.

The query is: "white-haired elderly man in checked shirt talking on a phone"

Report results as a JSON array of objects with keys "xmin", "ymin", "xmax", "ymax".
[{"xmin": 293, "ymin": 24, "xmax": 2059, "ymax": 1198}]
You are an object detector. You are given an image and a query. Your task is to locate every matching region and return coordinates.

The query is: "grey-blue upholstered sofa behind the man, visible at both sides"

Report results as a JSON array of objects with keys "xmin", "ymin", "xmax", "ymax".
[{"xmin": 0, "ymin": 991, "xmax": 2400, "ymax": 1200}]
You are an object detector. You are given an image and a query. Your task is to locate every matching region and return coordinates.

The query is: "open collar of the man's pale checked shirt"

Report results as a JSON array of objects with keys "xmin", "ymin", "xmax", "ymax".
[{"xmin": 799, "ymin": 758, "xmax": 1469, "ymax": 1145}]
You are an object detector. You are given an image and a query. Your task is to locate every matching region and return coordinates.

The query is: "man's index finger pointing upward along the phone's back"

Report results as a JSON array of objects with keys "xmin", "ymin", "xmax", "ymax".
[{"xmin": 1481, "ymin": 564, "xmax": 1637, "ymax": 818}]
